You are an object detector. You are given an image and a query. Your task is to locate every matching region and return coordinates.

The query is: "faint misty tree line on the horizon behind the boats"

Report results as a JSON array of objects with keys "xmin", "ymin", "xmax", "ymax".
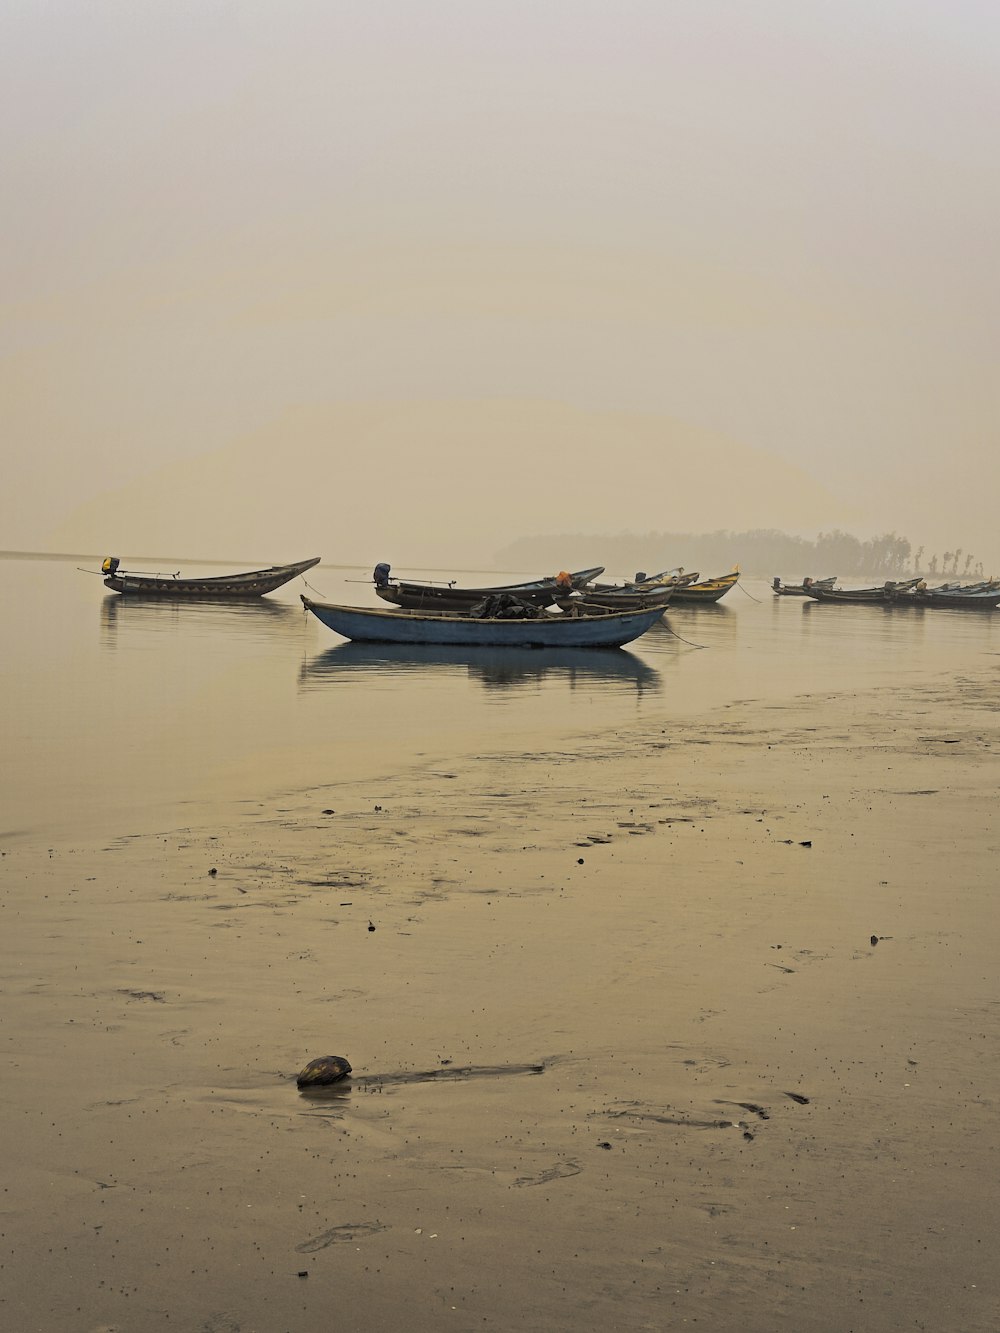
[{"xmin": 497, "ymin": 528, "xmax": 983, "ymax": 583}]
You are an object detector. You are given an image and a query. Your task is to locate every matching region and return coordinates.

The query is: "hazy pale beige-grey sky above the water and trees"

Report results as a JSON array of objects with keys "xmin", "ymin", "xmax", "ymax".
[{"xmin": 0, "ymin": 0, "xmax": 1000, "ymax": 576}]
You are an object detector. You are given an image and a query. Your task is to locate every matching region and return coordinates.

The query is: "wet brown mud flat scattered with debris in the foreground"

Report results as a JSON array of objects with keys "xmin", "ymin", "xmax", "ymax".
[{"xmin": 0, "ymin": 674, "xmax": 1000, "ymax": 1333}]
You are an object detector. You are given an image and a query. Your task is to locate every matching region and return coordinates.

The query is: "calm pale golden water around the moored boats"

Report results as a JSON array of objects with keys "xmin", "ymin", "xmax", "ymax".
[{"xmin": 0, "ymin": 559, "xmax": 1000, "ymax": 838}]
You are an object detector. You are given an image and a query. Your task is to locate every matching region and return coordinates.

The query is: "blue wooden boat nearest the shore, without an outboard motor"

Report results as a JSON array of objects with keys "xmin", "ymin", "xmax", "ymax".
[{"xmin": 301, "ymin": 595, "xmax": 663, "ymax": 648}]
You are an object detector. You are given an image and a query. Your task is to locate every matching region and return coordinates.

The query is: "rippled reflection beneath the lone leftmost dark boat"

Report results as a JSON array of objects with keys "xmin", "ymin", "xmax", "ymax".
[{"xmin": 100, "ymin": 596, "xmax": 304, "ymax": 648}]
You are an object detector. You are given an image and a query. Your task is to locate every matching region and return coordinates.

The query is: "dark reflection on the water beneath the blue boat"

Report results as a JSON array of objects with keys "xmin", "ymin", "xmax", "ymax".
[{"xmin": 299, "ymin": 643, "xmax": 661, "ymax": 694}]
